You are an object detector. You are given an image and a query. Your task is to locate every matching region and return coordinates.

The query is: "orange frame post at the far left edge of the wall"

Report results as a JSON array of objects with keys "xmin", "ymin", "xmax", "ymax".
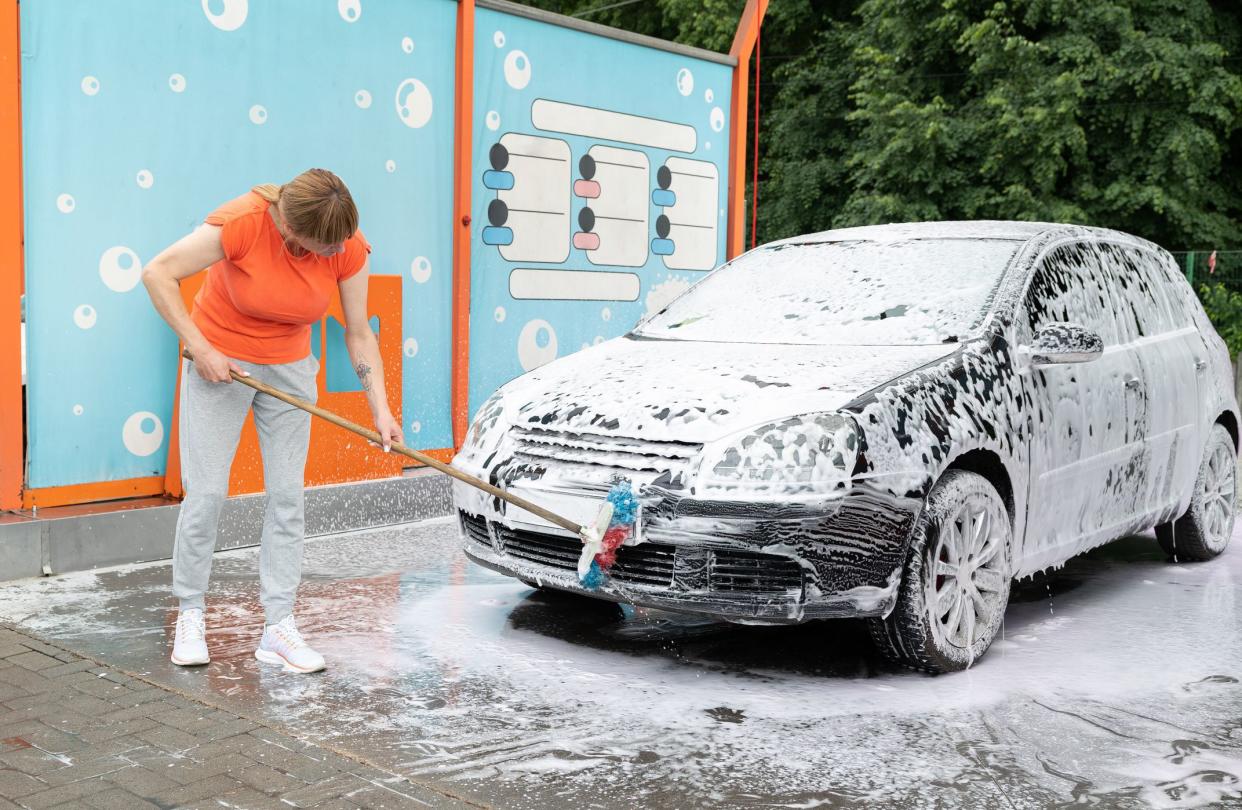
[{"xmin": 0, "ymin": 1, "xmax": 26, "ymax": 509}]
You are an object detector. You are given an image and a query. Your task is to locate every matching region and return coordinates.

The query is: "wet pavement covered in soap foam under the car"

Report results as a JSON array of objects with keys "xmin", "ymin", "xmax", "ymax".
[{"xmin": 0, "ymin": 518, "xmax": 1242, "ymax": 809}]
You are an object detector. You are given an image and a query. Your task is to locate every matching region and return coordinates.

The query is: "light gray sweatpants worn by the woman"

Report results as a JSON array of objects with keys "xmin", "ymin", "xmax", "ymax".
[{"xmin": 173, "ymin": 355, "xmax": 319, "ymax": 625}]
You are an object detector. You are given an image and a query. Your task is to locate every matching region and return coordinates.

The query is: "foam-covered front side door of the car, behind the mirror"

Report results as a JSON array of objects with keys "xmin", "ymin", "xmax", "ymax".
[{"xmin": 1015, "ymin": 241, "xmax": 1136, "ymax": 570}]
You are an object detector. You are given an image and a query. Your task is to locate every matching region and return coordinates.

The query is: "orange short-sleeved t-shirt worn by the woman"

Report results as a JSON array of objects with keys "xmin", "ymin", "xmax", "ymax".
[{"xmin": 190, "ymin": 191, "xmax": 371, "ymax": 364}]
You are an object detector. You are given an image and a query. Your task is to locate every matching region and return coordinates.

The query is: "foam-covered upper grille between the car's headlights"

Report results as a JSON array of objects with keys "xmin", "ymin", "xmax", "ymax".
[{"xmin": 510, "ymin": 427, "xmax": 703, "ymax": 477}]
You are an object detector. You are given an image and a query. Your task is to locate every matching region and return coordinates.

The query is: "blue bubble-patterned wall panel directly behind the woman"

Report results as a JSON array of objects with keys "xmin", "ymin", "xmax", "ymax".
[{"xmin": 20, "ymin": 0, "xmax": 457, "ymax": 487}]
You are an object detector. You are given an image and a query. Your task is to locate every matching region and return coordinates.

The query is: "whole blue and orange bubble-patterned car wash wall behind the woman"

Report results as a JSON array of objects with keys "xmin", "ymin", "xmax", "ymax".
[{"xmin": 0, "ymin": 0, "xmax": 737, "ymax": 508}]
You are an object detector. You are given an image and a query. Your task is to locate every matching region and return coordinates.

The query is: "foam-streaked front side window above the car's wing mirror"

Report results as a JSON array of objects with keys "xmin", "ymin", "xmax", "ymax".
[{"xmin": 1018, "ymin": 242, "xmax": 1118, "ymax": 345}]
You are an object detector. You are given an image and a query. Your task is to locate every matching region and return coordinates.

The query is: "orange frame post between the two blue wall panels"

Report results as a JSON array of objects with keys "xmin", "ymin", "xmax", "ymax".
[{"xmin": 451, "ymin": 0, "xmax": 474, "ymax": 448}]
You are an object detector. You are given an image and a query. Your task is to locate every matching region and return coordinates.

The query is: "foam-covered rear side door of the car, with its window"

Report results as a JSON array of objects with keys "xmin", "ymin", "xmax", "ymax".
[{"xmin": 1102, "ymin": 245, "xmax": 1203, "ymax": 529}]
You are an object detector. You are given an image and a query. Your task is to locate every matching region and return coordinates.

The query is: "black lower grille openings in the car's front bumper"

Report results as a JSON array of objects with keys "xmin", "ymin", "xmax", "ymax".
[{"xmin": 461, "ymin": 512, "xmax": 802, "ymax": 594}]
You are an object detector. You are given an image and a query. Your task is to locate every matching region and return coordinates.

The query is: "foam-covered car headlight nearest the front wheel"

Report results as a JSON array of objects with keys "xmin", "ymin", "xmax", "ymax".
[{"xmin": 698, "ymin": 414, "xmax": 859, "ymax": 499}]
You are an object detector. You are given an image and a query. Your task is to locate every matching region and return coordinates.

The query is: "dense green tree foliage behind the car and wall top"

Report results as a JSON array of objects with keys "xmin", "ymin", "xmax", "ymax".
[{"xmin": 514, "ymin": 0, "xmax": 1242, "ymax": 250}]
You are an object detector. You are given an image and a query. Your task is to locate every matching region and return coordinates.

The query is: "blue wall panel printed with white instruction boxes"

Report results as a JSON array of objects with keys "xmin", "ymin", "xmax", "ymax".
[{"xmin": 469, "ymin": 9, "xmax": 732, "ymax": 414}]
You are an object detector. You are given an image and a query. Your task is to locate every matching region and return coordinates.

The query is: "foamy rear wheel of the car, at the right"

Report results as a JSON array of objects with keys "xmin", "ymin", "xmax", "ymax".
[{"xmin": 1156, "ymin": 424, "xmax": 1238, "ymax": 563}]
